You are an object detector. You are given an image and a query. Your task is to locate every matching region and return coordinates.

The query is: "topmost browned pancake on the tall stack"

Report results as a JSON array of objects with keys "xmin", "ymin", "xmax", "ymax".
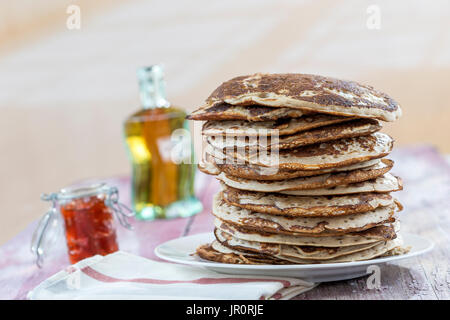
[{"xmin": 202, "ymin": 73, "xmax": 402, "ymax": 121}]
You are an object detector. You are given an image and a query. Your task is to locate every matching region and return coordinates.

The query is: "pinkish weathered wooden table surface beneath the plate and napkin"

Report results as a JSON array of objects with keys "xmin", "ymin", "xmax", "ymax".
[{"xmin": 0, "ymin": 146, "xmax": 450, "ymax": 300}]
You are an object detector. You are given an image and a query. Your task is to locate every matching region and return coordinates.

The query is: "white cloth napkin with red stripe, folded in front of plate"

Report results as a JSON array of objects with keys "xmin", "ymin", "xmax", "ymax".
[{"xmin": 28, "ymin": 251, "xmax": 316, "ymax": 300}]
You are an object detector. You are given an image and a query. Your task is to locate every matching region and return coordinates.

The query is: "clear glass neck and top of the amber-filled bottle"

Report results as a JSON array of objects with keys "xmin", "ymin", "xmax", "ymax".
[{"xmin": 138, "ymin": 65, "xmax": 170, "ymax": 109}]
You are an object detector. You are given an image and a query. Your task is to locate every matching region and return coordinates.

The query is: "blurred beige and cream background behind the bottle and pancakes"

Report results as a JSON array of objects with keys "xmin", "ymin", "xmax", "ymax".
[{"xmin": 0, "ymin": 0, "xmax": 450, "ymax": 244}]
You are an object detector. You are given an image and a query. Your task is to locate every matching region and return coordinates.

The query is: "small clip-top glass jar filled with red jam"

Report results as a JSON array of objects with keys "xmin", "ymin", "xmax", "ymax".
[{"xmin": 31, "ymin": 184, "xmax": 133, "ymax": 266}]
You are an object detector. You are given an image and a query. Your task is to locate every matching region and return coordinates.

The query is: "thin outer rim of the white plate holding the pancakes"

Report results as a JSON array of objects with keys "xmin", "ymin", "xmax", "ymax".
[{"xmin": 153, "ymin": 232, "xmax": 435, "ymax": 270}]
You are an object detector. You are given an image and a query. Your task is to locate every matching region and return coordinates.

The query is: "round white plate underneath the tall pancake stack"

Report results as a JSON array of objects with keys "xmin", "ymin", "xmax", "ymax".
[{"xmin": 155, "ymin": 232, "xmax": 434, "ymax": 282}]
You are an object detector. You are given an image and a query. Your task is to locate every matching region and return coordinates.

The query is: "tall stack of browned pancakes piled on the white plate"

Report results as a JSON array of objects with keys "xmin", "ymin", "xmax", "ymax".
[{"xmin": 188, "ymin": 74, "xmax": 406, "ymax": 264}]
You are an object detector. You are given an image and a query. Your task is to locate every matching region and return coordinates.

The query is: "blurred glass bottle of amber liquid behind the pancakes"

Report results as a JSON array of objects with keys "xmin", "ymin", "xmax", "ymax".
[{"xmin": 124, "ymin": 65, "xmax": 202, "ymax": 220}]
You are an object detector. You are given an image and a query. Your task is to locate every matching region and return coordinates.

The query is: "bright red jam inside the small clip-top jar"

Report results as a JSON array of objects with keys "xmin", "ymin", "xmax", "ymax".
[{"xmin": 60, "ymin": 194, "xmax": 119, "ymax": 263}]
